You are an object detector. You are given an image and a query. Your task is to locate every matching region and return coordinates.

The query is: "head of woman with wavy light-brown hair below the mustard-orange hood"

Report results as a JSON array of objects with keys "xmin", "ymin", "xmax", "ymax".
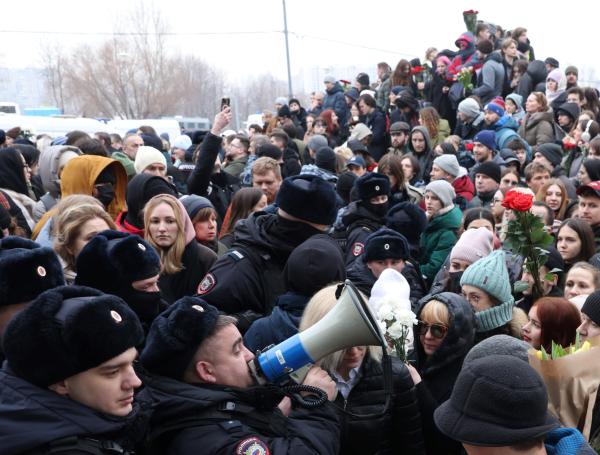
[{"xmin": 52, "ymin": 194, "xmax": 116, "ymax": 284}]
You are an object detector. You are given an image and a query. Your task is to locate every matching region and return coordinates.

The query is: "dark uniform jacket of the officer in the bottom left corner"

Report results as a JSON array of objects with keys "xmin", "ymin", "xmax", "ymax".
[{"xmin": 0, "ymin": 367, "xmax": 149, "ymax": 455}]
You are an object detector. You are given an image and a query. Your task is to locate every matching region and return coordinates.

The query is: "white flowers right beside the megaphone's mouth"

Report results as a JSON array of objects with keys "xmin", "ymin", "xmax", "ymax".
[{"xmin": 377, "ymin": 296, "xmax": 418, "ymax": 363}]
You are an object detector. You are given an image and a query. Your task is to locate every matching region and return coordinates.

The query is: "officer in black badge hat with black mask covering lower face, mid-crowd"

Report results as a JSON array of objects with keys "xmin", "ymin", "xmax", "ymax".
[{"xmin": 333, "ymin": 172, "xmax": 390, "ymax": 269}]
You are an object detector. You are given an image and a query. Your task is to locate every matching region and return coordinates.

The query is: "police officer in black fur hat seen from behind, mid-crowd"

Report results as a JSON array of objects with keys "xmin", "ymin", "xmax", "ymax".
[{"xmin": 198, "ymin": 175, "xmax": 338, "ymax": 332}]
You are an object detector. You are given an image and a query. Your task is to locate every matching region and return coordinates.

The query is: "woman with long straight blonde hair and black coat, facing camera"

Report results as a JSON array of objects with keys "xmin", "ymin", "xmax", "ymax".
[{"xmin": 144, "ymin": 194, "xmax": 217, "ymax": 303}]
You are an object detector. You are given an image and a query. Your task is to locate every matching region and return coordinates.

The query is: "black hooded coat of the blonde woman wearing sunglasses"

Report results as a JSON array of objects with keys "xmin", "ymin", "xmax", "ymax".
[{"xmin": 415, "ymin": 292, "xmax": 475, "ymax": 455}]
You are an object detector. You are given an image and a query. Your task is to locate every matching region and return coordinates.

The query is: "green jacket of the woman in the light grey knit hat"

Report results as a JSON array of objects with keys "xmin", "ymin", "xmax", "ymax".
[{"xmin": 420, "ymin": 205, "xmax": 462, "ymax": 284}]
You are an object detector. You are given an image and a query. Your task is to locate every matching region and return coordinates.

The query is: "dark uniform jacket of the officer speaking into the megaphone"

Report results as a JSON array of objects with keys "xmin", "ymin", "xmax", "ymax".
[{"xmin": 142, "ymin": 376, "xmax": 339, "ymax": 455}]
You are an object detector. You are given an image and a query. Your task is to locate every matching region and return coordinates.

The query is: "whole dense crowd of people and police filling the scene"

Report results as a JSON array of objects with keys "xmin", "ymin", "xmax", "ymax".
[{"xmin": 0, "ymin": 12, "xmax": 600, "ymax": 455}]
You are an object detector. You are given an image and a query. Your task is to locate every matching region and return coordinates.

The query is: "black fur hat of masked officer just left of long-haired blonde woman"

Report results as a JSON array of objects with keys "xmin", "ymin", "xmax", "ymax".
[{"xmin": 75, "ymin": 230, "xmax": 160, "ymax": 294}]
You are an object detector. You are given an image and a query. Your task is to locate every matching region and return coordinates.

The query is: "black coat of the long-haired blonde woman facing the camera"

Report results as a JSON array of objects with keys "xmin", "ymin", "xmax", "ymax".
[{"xmin": 158, "ymin": 239, "xmax": 217, "ymax": 303}]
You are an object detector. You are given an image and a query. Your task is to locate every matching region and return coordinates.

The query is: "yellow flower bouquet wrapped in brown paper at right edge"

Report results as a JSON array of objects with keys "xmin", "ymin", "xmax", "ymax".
[{"xmin": 529, "ymin": 336, "xmax": 600, "ymax": 440}]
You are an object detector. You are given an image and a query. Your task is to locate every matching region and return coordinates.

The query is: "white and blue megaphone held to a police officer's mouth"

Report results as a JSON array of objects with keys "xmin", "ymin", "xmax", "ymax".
[{"xmin": 249, "ymin": 280, "xmax": 385, "ymax": 384}]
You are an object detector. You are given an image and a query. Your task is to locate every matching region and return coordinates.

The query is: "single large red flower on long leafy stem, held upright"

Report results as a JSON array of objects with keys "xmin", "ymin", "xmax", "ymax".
[{"xmin": 502, "ymin": 189, "xmax": 557, "ymax": 302}]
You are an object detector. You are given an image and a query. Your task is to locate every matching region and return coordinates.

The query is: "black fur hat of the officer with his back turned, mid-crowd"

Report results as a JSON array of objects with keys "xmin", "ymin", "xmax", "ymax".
[{"xmin": 276, "ymin": 175, "xmax": 337, "ymax": 226}]
